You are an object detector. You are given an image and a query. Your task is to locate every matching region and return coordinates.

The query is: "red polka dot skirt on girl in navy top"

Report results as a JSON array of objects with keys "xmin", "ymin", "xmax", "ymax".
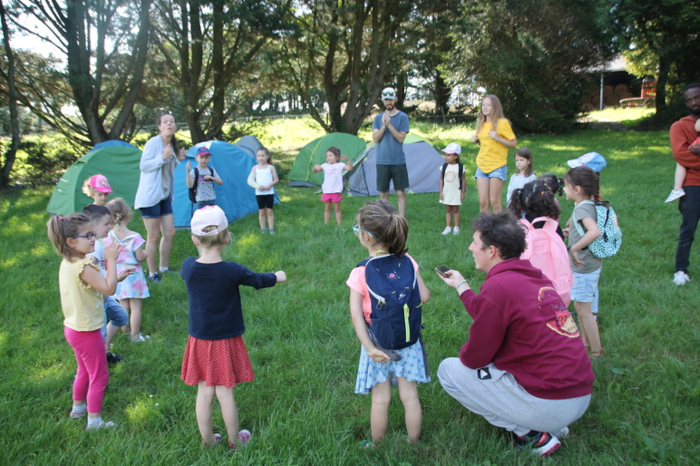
[{"xmin": 180, "ymin": 335, "xmax": 255, "ymax": 388}]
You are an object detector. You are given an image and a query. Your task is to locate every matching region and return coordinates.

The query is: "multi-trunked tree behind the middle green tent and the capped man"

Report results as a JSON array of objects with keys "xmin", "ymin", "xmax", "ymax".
[{"xmin": 272, "ymin": 0, "xmax": 412, "ymax": 134}]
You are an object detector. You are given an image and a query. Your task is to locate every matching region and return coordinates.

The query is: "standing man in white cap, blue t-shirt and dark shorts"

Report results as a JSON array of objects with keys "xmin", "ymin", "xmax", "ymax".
[{"xmin": 372, "ymin": 87, "xmax": 409, "ymax": 217}]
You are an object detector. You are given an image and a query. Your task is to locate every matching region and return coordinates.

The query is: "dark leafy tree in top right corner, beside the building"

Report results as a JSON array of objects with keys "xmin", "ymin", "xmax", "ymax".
[{"xmin": 610, "ymin": 0, "xmax": 700, "ymax": 113}]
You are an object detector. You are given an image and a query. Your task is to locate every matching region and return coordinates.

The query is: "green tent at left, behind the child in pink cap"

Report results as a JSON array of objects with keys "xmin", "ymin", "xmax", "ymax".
[{"xmin": 46, "ymin": 144, "xmax": 141, "ymax": 215}]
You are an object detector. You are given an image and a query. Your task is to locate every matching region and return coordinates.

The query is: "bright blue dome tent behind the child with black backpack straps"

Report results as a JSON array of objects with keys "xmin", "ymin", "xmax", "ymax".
[{"xmin": 173, "ymin": 141, "xmax": 279, "ymax": 228}]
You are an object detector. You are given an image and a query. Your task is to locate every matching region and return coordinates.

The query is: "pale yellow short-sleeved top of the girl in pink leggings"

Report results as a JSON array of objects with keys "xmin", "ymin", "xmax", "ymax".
[{"xmin": 58, "ymin": 257, "xmax": 104, "ymax": 332}]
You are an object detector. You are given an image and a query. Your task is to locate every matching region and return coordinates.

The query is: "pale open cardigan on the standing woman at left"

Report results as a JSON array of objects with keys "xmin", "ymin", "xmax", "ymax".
[{"xmin": 134, "ymin": 134, "xmax": 180, "ymax": 209}]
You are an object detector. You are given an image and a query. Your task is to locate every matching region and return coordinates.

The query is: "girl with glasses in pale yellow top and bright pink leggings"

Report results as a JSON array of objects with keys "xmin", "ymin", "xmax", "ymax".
[{"xmin": 46, "ymin": 214, "xmax": 131, "ymax": 430}]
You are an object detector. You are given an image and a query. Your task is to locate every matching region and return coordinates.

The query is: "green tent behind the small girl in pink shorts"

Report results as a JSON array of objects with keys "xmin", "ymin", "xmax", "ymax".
[{"xmin": 289, "ymin": 133, "xmax": 367, "ymax": 187}]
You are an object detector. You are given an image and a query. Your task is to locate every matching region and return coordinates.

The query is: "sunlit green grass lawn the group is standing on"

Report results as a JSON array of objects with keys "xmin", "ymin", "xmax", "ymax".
[{"xmin": 0, "ymin": 120, "xmax": 700, "ymax": 465}]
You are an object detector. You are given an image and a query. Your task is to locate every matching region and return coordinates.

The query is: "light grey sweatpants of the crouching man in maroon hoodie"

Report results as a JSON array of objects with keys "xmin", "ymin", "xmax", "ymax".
[{"xmin": 438, "ymin": 358, "xmax": 591, "ymax": 437}]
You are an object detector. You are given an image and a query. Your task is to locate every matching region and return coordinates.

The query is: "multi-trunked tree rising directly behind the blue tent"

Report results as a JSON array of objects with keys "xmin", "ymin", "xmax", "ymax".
[{"xmin": 155, "ymin": 0, "xmax": 291, "ymax": 143}]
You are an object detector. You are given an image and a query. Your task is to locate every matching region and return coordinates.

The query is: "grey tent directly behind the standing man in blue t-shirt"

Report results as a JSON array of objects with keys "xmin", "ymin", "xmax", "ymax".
[{"xmin": 348, "ymin": 133, "xmax": 445, "ymax": 196}]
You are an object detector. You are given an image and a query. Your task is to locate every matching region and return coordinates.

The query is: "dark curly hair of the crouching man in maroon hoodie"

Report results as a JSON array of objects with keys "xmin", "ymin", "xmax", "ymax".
[{"xmin": 472, "ymin": 210, "xmax": 526, "ymax": 260}]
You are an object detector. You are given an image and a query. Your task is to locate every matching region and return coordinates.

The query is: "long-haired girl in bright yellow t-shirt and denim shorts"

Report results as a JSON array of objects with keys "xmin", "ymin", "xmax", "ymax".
[{"xmin": 472, "ymin": 94, "xmax": 518, "ymax": 212}]
